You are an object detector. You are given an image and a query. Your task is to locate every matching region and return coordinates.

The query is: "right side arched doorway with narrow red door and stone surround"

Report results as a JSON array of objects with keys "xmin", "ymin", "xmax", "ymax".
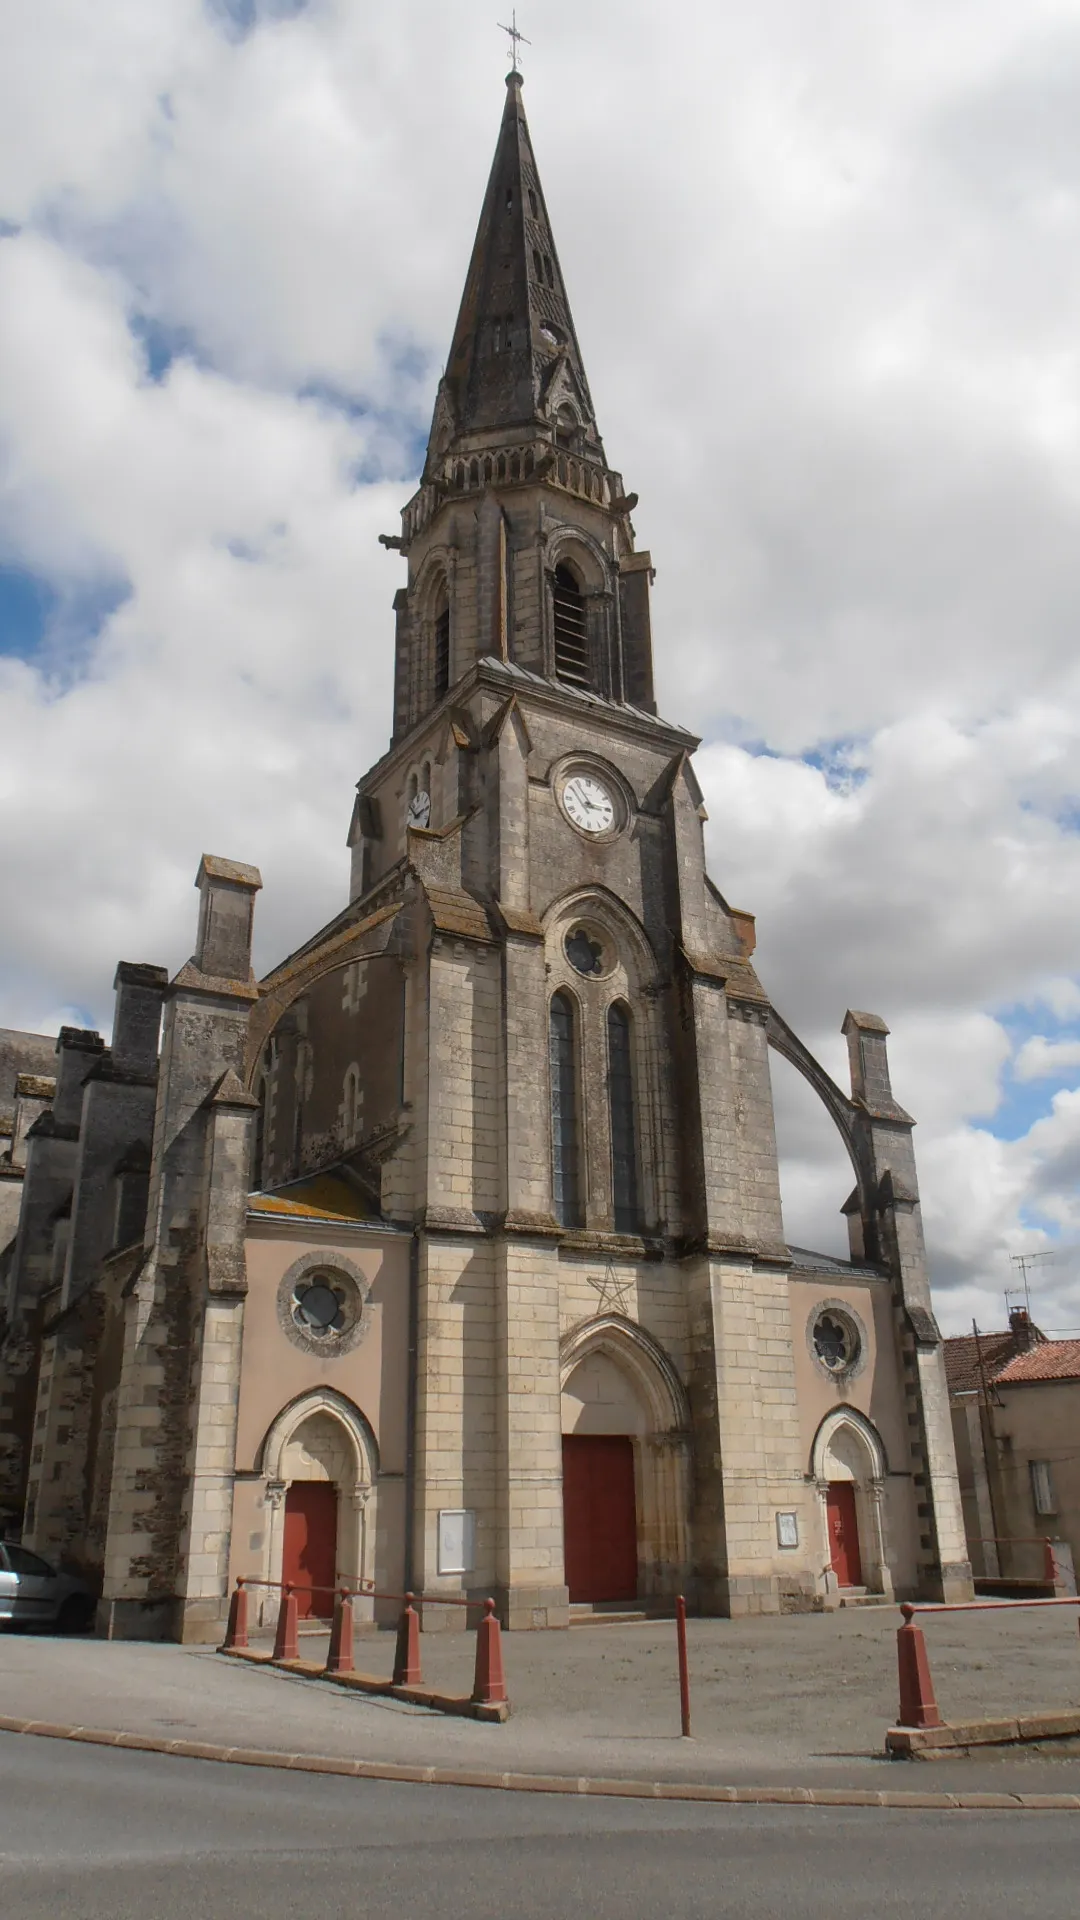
[{"xmin": 813, "ymin": 1407, "xmax": 892, "ymax": 1594}]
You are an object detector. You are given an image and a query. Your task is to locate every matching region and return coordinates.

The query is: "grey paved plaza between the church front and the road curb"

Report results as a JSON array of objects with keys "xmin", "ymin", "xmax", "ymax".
[{"xmin": 0, "ymin": 1607, "xmax": 1080, "ymax": 1791}]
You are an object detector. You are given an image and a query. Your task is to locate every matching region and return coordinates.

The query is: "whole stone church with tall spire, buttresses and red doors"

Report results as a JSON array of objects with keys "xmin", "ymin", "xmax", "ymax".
[{"xmin": 0, "ymin": 73, "xmax": 970, "ymax": 1642}]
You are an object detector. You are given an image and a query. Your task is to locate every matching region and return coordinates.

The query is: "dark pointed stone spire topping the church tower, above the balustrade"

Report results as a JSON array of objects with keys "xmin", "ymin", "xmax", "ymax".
[{"xmin": 429, "ymin": 71, "xmax": 603, "ymax": 480}]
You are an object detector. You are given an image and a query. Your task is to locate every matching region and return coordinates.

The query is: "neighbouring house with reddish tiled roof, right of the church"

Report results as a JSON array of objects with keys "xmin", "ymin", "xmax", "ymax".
[{"xmin": 945, "ymin": 1308, "xmax": 1080, "ymax": 1586}]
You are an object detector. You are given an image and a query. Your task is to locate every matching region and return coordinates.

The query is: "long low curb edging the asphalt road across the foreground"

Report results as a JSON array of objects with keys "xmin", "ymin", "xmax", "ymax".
[{"xmin": 0, "ymin": 1715, "xmax": 1080, "ymax": 1812}]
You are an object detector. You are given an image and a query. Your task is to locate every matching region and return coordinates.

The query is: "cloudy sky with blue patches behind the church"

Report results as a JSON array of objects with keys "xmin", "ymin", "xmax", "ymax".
[{"xmin": 0, "ymin": 0, "xmax": 1080, "ymax": 1331}]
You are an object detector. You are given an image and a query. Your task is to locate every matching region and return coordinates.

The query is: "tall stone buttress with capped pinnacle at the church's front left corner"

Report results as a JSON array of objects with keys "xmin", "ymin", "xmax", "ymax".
[{"xmin": 98, "ymin": 856, "xmax": 261, "ymax": 1640}]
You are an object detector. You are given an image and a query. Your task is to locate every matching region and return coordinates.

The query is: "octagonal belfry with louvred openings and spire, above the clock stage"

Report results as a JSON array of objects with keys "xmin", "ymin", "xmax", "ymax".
[{"xmin": 382, "ymin": 73, "xmax": 655, "ymax": 743}]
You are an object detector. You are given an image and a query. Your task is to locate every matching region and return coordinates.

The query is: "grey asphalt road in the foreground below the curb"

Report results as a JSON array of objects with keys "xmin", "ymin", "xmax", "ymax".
[{"xmin": 0, "ymin": 1734, "xmax": 1080, "ymax": 1920}]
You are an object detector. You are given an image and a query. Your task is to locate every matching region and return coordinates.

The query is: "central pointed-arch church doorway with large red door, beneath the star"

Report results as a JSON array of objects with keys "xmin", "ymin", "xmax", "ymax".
[{"xmin": 561, "ymin": 1315, "xmax": 690, "ymax": 1605}]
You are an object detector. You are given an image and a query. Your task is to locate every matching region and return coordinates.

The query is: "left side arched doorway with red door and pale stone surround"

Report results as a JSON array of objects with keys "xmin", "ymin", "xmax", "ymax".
[{"xmin": 261, "ymin": 1388, "xmax": 379, "ymax": 1619}]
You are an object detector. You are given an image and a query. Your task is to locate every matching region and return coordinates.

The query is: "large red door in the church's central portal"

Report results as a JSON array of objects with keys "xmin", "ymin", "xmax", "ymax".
[{"xmin": 563, "ymin": 1434, "xmax": 638, "ymax": 1601}]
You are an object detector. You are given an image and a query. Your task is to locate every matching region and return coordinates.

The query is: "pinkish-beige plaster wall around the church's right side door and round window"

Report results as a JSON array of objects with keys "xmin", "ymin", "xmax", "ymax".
[{"xmin": 790, "ymin": 1273, "xmax": 919, "ymax": 1597}]
